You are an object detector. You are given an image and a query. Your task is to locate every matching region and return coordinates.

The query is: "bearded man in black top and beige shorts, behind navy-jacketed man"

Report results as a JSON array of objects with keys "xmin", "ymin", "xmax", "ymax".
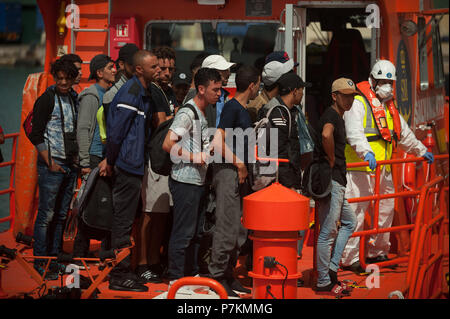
[{"xmin": 136, "ymin": 47, "xmax": 178, "ymax": 283}]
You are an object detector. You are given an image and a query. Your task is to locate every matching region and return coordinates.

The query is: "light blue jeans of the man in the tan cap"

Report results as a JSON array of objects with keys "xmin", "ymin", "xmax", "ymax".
[{"xmin": 317, "ymin": 180, "xmax": 356, "ymax": 287}]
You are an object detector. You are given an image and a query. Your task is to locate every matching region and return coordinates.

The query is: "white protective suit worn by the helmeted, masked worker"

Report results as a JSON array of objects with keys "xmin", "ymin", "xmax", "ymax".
[{"xmin": 341, "ymin": 99, "xmax": 427, "ymax": 266}]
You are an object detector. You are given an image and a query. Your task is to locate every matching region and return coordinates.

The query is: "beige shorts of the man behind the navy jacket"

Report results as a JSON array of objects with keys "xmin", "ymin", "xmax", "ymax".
[{"xmin": 142, "ymin": 162, "xmax": 173, "ymax": 213}]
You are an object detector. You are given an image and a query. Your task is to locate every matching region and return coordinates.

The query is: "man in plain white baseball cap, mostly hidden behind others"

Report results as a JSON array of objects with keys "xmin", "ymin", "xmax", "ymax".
[{"xmin": 202, "ymin": 54, "xmax": 235, "ymax": 127}]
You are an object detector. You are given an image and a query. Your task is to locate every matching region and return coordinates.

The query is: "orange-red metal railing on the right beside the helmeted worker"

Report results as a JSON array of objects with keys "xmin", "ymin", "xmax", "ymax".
[{"xmin": 314, "ymin": 154, "xmax": 449, "ymax": 298}]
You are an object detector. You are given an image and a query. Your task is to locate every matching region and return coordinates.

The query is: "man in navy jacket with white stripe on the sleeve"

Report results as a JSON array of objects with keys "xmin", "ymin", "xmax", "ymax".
[{"xmin": 100, "ymin": 50, "xmax": 161, "ymax": 292}]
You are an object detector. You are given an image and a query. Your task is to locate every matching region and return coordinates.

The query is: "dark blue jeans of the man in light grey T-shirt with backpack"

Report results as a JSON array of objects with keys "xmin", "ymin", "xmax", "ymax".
[{"xmin": 168, "ymin": 178, "xmax": 205, "ymax": 280}]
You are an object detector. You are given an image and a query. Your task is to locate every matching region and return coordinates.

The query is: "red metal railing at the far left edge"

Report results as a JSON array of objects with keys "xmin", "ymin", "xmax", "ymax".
[{"xmin": 0, "ymin": 133, "xmax": 19, "ymax": 230}]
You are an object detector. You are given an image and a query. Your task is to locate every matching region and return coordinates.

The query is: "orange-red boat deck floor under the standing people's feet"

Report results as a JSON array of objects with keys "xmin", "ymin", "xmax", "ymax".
[{"xmin": 0, "ymin": 232, "xmax": 449, "ymax": 299}]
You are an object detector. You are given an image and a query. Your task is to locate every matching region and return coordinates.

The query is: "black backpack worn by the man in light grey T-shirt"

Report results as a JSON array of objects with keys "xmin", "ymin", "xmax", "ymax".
[{"xmin": 149, "ymin": 104, "xmax": 199, "ymax": 176}]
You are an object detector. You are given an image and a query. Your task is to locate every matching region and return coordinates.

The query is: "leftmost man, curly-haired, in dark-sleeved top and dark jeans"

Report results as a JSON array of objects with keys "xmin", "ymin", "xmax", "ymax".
[{"xmin": 30, "ymin": 60, "xmax": 78, "ymax": 280}]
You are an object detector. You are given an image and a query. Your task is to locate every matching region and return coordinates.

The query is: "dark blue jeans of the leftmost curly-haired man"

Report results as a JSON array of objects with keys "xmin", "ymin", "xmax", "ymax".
[{"xmin": 33, "ymin": 161, "xmax": 77, "ymax": 264}]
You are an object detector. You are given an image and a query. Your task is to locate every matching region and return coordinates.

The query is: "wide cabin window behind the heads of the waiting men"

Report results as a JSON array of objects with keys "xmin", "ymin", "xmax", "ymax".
[{"xmin": 145, "ymin": 21, "xmax": 279, "ymax": 72}]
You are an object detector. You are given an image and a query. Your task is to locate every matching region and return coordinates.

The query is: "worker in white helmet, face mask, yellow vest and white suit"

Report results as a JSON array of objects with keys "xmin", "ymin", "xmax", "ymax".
[{"xmin": 341, "ymin": 60, "xmax": 434, "ymax": 273}]
